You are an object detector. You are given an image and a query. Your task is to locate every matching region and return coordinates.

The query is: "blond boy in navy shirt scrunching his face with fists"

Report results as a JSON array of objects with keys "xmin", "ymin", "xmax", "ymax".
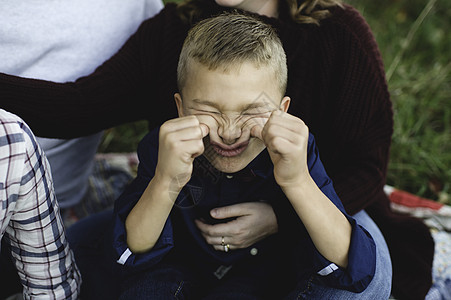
[{"xmin": 114, "ymin": 14, "xmax": 375, "ymax": 299}]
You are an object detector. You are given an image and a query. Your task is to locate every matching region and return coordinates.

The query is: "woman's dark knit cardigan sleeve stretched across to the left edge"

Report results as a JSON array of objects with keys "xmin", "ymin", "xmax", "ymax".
[{"xmin": 0, "ymin": 5, "xmax": 182, "ymax": 138}]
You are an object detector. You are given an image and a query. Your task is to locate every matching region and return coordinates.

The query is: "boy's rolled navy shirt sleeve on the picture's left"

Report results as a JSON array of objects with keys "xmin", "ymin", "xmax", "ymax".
[{"xmin": 113, "ymin": 131, "xmax": 174, "ymax": 271}]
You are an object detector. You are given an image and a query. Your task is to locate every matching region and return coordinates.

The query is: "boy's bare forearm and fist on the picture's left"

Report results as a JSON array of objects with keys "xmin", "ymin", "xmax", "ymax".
[{"xmin": 125, "ymin": 116, "xmax": 208, "ymax": 253}]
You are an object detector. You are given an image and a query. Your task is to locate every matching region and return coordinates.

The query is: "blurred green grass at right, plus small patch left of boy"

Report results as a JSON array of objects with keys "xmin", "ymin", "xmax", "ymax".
[{"xmin": 100, "ymin": 0, "xmax": 451, "ymax": 204}]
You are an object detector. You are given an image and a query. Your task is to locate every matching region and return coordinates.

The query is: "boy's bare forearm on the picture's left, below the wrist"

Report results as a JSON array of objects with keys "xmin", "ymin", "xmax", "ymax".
[{"xmin": 125, "ymin": 175, "xmax": 176, "ymax": 253}]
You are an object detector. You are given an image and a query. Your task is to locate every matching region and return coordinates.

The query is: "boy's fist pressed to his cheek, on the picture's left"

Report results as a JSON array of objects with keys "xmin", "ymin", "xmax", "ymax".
[{"xmin": 155, "ymin": 116, "xmax": 209, "ymax": 193}]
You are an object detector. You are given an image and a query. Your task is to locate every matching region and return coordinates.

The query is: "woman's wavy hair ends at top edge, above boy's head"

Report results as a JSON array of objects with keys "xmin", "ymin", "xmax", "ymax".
[{"xmin": 177, "ymin": 0, "xmax": 343, "ymax": 25}]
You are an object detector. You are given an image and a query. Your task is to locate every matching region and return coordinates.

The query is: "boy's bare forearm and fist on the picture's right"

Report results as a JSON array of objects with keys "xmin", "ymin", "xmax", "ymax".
[{"xmin": 252, "ymin": 111, "xmax": 352, "ymax": 267}]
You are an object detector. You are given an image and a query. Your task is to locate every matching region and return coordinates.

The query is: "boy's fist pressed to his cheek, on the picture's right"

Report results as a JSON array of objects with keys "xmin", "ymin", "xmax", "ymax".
[{"xmin": 251, "ymin": 110, "xmax": 310, "ymax": 188}]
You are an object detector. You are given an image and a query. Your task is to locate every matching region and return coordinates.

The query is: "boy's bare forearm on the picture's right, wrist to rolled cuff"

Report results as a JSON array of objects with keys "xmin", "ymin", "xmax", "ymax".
[{"xmin": 283, "ymin": 177, "xmax": 352, "ymax": 267}]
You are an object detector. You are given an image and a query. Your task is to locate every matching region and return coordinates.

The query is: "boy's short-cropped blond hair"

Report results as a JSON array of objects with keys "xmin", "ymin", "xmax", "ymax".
[{"xmin": 177, "ymin": 12, "xmax": 287, "ymax": 94}]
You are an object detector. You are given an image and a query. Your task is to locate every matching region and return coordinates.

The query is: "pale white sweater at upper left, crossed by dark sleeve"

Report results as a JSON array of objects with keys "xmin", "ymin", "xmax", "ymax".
[{"xmin": 0, "ymin": 0, "xmax": 163, "ymax": 208}]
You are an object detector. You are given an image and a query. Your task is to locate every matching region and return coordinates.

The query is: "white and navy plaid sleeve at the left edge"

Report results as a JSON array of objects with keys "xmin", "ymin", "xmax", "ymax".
[{"xmin": 0, "ymin": 110, "xmax": 81, "ymax": 299}]
